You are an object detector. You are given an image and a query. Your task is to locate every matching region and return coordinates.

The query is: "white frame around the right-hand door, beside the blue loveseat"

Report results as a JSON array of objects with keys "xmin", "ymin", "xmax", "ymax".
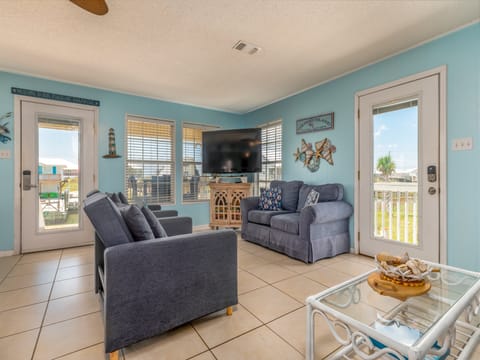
[{"xmin": 353, "ymin": 65, "xmax": 448, "ymax": 264}]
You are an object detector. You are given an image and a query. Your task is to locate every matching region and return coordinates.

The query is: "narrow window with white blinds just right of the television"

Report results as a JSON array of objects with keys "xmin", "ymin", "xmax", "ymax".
[{"xmin": 258, "ymin": 120, "xmax": 282, "ymax": 190}]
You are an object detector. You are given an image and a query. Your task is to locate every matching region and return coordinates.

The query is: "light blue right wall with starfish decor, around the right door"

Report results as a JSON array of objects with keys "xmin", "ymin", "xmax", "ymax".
[{"xmin": 247, "ymin": 23, "xmax": 480, "ymax": 270}]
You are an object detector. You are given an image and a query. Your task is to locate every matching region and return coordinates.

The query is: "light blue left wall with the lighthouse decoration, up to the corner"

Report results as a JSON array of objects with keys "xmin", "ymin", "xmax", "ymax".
[{"xmin": 0, "ymin": 72, "xmax": 240, "ymax": 251}]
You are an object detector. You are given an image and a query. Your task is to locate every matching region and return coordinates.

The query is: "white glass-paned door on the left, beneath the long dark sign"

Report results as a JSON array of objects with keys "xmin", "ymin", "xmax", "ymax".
[{"xmin": 20, "ymin": 100, "xmax": 97, "ymax": 252}]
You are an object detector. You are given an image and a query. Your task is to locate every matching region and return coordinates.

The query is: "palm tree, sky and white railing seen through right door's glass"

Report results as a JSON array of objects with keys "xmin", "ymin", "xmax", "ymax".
[{"xmin": 372, "ymin": 99, "xmax": 419, "ymax": 245}]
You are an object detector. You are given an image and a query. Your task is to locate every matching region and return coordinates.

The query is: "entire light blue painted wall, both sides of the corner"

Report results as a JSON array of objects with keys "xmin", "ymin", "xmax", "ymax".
[{"xmin": 0, "ymin": 23, "xmax": 480, "ymax": 270}]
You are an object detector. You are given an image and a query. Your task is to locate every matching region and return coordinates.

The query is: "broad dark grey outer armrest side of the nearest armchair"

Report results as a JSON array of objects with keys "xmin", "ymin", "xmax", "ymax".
[{"xmin": 104, "ymin": 230, "xmax": 238, "ymax": 352}]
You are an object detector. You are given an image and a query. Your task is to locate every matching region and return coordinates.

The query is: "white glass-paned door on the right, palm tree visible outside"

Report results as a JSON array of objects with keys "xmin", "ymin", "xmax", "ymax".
[{"xmin": 356, "ymin": 75, "xmax": 440, "ymax": 262}]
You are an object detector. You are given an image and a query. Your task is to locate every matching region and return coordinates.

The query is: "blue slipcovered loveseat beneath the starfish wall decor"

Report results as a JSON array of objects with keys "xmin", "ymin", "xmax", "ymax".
[{"xmin": 240, "ymin": 181, "xmax": 353, "ymax": 263}]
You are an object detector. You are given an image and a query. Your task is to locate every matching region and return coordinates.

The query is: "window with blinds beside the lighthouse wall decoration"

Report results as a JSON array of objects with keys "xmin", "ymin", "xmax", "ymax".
[{"xmin": 125, "ymin": 116, "xmax": 175, "ymax": 204}]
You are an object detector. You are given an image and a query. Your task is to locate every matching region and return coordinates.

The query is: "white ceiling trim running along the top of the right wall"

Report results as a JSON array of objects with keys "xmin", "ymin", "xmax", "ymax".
[{"xmin": 246, "ymin": 20, "xmax": 480, "ymax": 115}]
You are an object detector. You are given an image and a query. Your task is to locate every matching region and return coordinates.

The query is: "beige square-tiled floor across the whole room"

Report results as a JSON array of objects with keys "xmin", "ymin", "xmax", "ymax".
[{"xmin": 0, "ymin": 235, "xmax": 480, "ymax": 360}]
